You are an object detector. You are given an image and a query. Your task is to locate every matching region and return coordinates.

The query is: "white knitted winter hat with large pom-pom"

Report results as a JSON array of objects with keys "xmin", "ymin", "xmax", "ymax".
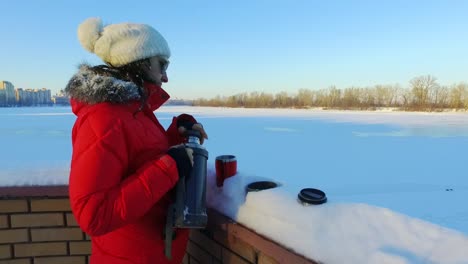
[{"xmin": 78, "ymin": 17, "xmax": 171, "ymax": 67}]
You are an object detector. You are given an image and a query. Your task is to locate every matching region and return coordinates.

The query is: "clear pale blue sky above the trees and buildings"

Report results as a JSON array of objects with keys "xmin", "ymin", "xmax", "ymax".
[{"xmin": 0, "ymin": 0, "xmax": 468, "ymax": 99}]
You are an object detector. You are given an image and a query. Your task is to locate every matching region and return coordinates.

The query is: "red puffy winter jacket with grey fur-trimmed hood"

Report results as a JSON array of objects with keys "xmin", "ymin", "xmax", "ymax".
[{"xmin": 66, "ymin": 65, "xmax": 195, "ymax": 264}]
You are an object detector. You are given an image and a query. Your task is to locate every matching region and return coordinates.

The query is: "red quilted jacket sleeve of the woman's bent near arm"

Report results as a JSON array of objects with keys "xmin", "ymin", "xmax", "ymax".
[{"xmin": 69, "ymin": 114, "xmax": 178, "ymax": 236}]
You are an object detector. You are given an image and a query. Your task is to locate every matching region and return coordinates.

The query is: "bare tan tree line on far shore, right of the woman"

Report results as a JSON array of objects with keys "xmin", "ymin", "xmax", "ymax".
[{"xmin": 193, "ymin": 75, "xmax": 468, "ymax": 111}]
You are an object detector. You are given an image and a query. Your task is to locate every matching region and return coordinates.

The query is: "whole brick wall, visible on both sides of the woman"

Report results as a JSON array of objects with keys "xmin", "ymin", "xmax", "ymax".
[{"xmin": 0, "ymin": 186, "xmax": 316, "ymax": 264}]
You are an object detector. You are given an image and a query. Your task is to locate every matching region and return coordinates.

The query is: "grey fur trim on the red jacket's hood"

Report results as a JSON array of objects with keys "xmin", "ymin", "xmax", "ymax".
[{"xmin": 65, "ymin": 64, "xmax": 141, "ymax": 104}]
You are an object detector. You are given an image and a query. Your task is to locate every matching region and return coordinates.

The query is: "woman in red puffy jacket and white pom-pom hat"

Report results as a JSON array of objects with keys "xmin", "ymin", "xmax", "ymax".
[{"xmin": 65, "ymin": 18, "xmax": 207, "ymax": 264}]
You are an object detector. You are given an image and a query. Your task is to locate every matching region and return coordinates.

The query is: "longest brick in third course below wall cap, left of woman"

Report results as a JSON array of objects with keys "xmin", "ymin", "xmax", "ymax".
[{"xmin": 31, "ymin": 227, "xmax": 83, "ymax": 241}]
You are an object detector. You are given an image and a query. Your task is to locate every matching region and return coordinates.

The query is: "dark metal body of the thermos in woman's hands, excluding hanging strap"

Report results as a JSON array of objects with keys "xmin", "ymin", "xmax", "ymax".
[{"xmin": 174, "ymin": 130, "xmax": 208, "ymax": 228}]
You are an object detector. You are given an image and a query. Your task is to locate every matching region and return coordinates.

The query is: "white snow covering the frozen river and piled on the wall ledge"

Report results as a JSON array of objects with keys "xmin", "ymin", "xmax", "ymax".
[{"xmin": 0, "ymin": 106, "xmax": 468, "ymax": 263}]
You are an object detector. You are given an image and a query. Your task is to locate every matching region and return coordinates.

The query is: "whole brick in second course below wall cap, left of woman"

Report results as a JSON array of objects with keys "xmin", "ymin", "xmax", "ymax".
[{"xmin": 10, "ymin": 213, "xmax": 64, "ymax": 227}]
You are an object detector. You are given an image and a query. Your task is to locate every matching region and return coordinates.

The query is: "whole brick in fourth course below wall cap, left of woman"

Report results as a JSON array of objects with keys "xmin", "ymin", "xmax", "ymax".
[{"xmin": 13, "ymin": 242, "xmax": 67, "ymax": 257}]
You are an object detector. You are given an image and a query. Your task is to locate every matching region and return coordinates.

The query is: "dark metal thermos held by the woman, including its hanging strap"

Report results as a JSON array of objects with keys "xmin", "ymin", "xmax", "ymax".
[{"xmin": 164, "ymin": 130, "xmax": 208, "ymax": 259}]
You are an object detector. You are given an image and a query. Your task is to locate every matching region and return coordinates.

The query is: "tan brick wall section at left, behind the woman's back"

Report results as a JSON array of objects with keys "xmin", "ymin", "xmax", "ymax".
[{"xmin": 0, "ymin": 188, "xmax": 91, "ymax": 264}]
